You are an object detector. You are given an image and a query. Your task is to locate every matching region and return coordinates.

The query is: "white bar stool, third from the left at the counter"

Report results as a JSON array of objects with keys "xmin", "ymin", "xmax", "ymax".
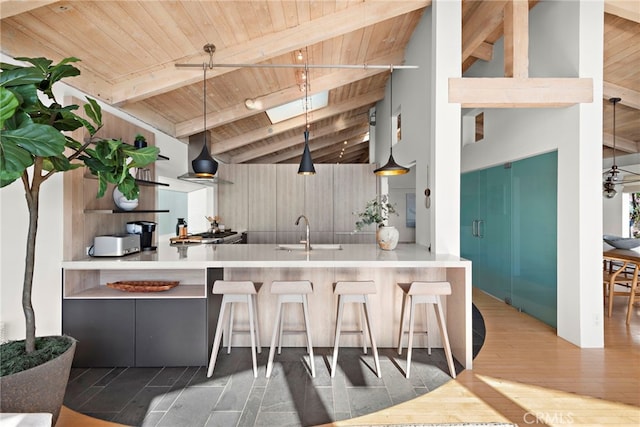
[{"xmin": 331, "ymin": 281, "xmax": 382, "ymax": 378}]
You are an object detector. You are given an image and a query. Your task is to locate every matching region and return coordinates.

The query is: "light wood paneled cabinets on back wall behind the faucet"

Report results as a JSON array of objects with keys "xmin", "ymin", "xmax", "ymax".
[{"xmin": 218, "ymin": 164, "xmax": 377, "ymax": 243}]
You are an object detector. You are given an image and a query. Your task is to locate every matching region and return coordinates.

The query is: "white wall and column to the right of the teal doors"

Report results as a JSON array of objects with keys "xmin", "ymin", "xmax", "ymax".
[{"xmin": 462, "ymin": 1, "xmax": 603, "ymax": 347}]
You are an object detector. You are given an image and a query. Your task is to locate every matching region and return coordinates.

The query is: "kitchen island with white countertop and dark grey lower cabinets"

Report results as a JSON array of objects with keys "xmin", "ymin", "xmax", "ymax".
[{"xmin": 62, "ymin": 243, "xmax": 472, "ymax": 369}]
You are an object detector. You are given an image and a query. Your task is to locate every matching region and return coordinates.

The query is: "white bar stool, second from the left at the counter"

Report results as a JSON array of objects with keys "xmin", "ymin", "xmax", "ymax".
[{"xmin": 266, "ymin": 280, "xmax": 316, "ymax": 378}]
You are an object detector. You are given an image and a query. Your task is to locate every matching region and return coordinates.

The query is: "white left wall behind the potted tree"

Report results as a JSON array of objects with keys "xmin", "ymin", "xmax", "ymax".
[{"xmin": 0, "ymin": 54, "xmax": 187, "ymax": 339}]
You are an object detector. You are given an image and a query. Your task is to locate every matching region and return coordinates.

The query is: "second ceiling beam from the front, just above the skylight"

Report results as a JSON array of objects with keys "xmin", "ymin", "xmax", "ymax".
[{"xmin": 176, "ymin": 52, "xmax": 404, "ymax": 138}]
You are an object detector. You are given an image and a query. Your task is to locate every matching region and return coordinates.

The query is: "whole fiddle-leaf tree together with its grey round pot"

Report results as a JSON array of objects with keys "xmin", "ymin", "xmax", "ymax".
[{"xmin": 0, "ymin": 58, "xmax": 158, "ymax": 425}]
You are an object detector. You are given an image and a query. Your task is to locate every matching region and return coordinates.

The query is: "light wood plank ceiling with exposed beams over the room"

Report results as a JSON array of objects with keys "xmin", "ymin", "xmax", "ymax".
[{"xmin": 0, "ymin": 0, "xmax": 640, "ymax": 167}]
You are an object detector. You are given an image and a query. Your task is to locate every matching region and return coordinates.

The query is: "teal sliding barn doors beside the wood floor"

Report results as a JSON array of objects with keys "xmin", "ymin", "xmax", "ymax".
[{"xmin": 460, "ymin": 152, "xmax": 557, "ymax": 327}]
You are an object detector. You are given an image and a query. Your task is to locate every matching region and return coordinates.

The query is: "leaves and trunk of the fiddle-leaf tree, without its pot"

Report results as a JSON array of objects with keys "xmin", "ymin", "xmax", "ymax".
[{"xmin": 0, "ymin": 58, "xmax": 158, "ymax": 353}]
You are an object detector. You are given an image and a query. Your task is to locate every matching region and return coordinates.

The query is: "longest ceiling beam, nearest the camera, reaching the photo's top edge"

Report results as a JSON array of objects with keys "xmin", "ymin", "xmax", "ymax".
[{"xmin": 110, "ymin": 0, "xmax": 431, "ymax": 105}]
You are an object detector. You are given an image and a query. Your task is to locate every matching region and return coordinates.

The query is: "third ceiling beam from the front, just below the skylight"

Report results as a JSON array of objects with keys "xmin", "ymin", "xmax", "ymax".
[{"xmin": 211, "ymin": 88, "xmax": 384, "ymax": 154}]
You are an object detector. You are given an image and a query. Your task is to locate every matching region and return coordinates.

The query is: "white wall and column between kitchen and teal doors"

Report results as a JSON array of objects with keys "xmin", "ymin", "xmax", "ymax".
[{"xmin": 375, "ymin": 2, "xmax": 461, "ymax": 255}]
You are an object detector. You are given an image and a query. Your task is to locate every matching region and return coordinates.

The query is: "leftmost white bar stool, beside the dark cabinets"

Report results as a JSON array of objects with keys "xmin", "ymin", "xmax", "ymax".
[{"xmin": 207, "ymin": 280, "xmax": 262, "ymax": 378}]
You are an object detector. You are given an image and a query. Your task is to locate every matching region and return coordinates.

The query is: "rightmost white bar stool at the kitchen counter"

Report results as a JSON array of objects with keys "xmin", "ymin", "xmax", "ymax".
[{"xmin": 398, "ymin": 282, "xmax": 456, "ymax": 378}]
